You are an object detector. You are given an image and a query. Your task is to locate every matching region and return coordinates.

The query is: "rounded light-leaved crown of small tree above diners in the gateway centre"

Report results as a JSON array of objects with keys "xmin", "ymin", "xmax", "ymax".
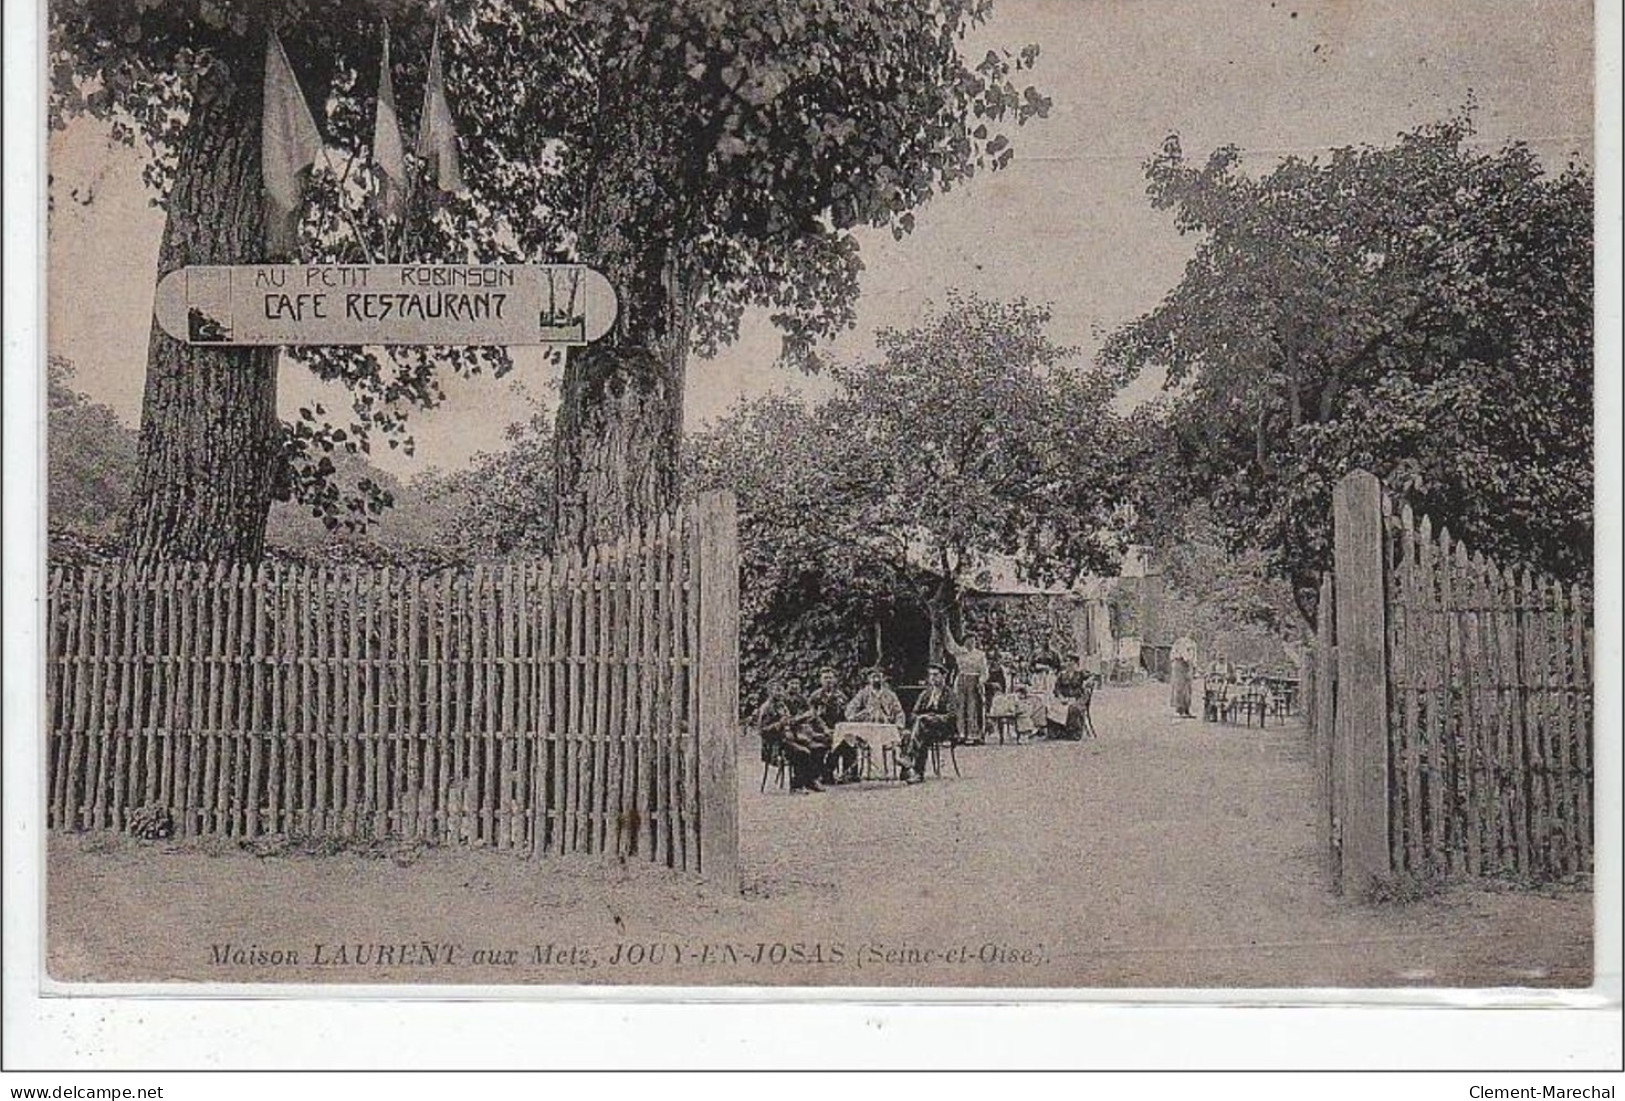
[{"xmin": 827, "ymin": 294, "xmax": 1129, "ymax": 646}]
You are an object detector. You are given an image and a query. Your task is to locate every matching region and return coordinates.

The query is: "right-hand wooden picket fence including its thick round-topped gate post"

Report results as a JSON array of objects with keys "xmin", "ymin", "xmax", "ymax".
[{"xmin": 1311, "ymin": 471, "xmax": 1594, "ymax": 888}]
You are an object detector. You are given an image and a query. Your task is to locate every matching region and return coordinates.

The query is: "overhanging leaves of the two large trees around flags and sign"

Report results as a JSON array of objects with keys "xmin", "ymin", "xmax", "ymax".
[{"xmin": 50, "ymin": 0, "xmax": 1050, "ymax": 552}]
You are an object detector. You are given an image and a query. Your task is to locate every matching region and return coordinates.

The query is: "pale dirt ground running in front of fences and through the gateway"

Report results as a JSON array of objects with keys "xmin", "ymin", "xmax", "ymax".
[{"xmin": 49, "ymin": 685, "xmax": 1593, "ymax": 987}]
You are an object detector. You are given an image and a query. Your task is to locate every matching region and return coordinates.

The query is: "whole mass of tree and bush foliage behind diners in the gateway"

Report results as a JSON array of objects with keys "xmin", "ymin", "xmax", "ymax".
[{"xmin": 691, "ymin": 294, "xmax": 1129, "ymax": 695}]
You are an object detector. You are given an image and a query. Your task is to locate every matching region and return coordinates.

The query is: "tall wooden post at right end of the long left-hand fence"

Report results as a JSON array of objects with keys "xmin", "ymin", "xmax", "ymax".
[{"xmin": 694, "ymin": 492, "xmax": 741, "ymax": 893}]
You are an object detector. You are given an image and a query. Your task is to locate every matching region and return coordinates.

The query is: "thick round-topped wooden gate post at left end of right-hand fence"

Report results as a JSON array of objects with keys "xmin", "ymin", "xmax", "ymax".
[{"xmin": 1333, "ymin": 471, "xmax": 1393, "ymax": 890}]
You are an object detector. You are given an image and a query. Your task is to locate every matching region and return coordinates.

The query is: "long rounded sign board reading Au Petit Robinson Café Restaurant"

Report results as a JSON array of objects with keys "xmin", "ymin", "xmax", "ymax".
[{"xmin": 153, "ymin": 263, "xmax": 618, "ymax": 344}]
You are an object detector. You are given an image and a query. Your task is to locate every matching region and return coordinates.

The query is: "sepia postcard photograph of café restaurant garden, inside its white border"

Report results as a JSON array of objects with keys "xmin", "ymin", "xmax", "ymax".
[{"xmin": 38, "ymin": 0, "xmax": 1599, "ymax": 991}]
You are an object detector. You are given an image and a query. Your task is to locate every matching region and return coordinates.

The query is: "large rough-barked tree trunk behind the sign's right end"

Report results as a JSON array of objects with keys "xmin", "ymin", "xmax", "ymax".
[{"xmin": 554, "ymin": 108, "xmax": 694, "ymax": 549}]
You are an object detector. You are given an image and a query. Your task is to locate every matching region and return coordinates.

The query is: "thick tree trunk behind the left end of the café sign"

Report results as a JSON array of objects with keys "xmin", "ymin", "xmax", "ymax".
[{"xmin": 127, "ymin": 55, "xmax": 281, "ymax": 562}]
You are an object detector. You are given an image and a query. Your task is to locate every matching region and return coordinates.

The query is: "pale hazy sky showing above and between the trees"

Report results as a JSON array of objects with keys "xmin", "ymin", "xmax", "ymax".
[{"xmin": 47, "ymin": 0, "xmax": 1593, "ymax": 476}]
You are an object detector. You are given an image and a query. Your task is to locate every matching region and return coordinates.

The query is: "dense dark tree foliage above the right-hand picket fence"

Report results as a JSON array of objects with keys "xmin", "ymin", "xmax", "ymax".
[{"xmin": 1102, "ymin": 114, "xmax": 1593, "ymax": 611}]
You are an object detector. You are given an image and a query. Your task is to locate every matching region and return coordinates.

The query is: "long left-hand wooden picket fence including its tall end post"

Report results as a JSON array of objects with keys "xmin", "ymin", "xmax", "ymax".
[{"xmin": 47, "ymin": 494, "xmax": 738, "ymax": 877}]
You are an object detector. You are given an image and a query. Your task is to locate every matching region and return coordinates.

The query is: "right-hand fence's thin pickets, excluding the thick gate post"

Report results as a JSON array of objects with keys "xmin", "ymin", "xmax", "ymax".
[{"xmin": 1383, "ymin": 499, "xmax": 1593, "ymax": 879}]
